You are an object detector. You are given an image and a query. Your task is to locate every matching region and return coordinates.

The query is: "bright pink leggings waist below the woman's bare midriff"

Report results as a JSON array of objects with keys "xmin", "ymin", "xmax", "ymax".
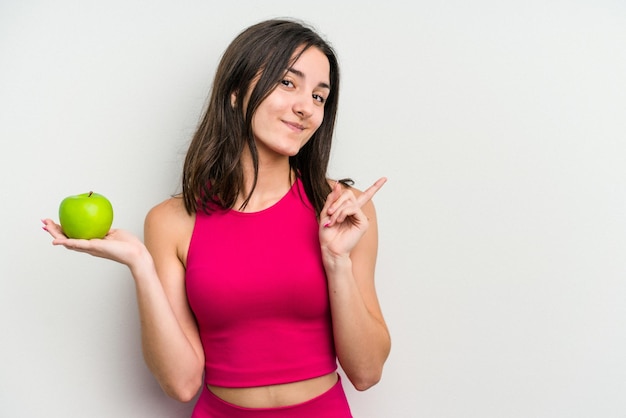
[{"xmin": 191, "ymin": 379, "xmax": 352, "ymax": 418}]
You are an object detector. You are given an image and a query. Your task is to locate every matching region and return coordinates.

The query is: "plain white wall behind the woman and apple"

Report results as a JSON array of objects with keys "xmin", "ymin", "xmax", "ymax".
[{"xmin": 0, "ymin": 0, "xmax": 626, "ymax": 418}]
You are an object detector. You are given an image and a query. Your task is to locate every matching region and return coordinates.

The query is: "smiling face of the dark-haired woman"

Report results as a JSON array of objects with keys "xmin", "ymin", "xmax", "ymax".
[{"xmin": 244, "ymin": 47, "xmax": 330, "ymax": 158}]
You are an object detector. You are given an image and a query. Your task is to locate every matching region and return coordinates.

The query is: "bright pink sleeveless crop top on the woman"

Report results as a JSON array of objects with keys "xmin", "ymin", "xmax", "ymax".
[{"xmin": 186, "ymin": 180, "xmax": 337, "ymax": 387}]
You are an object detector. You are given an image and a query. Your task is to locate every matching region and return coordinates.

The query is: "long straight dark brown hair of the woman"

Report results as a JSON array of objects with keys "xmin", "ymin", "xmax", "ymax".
[{"xmin": 182, "ymin": 20, "xmax": 339, "ymax": 215}]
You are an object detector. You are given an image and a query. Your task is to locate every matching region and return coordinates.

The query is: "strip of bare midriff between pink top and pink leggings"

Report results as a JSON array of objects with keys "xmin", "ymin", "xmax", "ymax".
[{"xmin": 207, "ymin": 372, "xmax": 338, "ymax": 408}]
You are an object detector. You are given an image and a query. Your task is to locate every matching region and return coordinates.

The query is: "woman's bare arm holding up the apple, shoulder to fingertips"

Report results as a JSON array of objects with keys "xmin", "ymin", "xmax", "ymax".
[{"xmin": 44, "ymin": 199, "xmax": 204, "ymax": 401}]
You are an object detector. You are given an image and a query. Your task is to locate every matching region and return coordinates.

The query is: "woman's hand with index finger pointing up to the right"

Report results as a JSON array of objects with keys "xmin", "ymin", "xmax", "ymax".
[{"xmin": 319, "ymin": 177, "xmax": 387, "ymax": 258}]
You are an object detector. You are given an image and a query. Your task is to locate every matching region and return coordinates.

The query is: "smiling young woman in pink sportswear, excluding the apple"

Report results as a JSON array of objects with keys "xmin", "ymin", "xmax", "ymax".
[{"xmin": 44, "ymin": 20, "xmax": 390, "ymax": 418}]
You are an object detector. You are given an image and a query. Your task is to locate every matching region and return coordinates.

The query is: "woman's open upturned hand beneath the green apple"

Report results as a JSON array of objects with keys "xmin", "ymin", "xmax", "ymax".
[{"xmin": 41, "ymin": 219, "xmax": 148, "ymax": 269}]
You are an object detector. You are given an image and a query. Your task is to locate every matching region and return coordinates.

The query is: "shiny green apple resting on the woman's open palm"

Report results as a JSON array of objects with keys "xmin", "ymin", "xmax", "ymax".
[{"xmin": 59, "ymin": 192, "xmax": 113, "ymax": 239}]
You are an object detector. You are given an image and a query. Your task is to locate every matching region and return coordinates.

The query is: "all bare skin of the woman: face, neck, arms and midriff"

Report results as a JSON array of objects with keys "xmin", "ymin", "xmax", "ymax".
[{"xmin": 43, "ymin": 48, "xmax": 390, "ymax": 408}]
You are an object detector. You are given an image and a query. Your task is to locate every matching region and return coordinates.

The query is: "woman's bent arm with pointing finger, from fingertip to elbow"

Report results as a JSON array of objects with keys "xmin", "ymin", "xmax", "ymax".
[{"xmin": 320, "ymin": 179, "xmax": 391, "ymax": 390}]
